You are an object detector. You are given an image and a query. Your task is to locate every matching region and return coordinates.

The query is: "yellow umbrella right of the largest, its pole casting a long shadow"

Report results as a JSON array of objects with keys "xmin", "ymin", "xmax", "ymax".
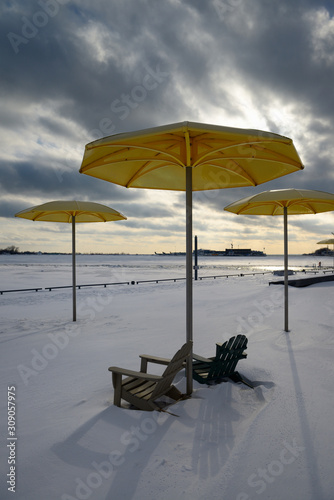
[{"xmin": 224, "ymin": 189, "xmax": 334, "ymax": 332}]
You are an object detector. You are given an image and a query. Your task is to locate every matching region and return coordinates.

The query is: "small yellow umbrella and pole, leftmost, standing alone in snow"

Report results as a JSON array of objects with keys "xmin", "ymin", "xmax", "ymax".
[{"xmin": 15, "ymin": 201, "xmax": 126, "ymax": 321}]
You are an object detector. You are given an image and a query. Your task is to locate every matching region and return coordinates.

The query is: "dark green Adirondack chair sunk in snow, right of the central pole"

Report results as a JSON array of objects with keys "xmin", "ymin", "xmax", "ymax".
[{"xmin": 193, "ymin": 335, "xmax": 252, "ymax": 387}]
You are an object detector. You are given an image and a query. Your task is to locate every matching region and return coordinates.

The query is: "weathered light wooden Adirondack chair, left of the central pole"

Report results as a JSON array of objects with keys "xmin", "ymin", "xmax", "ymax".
[{"xmin": 108, "ymin": 342, "xmax": 192, "ymax": 411}]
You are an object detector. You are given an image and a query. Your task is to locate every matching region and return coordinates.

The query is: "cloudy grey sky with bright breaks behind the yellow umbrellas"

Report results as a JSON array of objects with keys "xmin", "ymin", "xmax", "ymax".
[{"xmin": 0, "ymin": 0, "xmax": 334, "ymax": 254}]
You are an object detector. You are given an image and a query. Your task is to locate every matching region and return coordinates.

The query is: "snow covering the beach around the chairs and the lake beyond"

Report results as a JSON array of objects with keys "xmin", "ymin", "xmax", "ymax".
[{"xmin": 0, "ymin": 255, "xmax": 334, "ymax": 500}]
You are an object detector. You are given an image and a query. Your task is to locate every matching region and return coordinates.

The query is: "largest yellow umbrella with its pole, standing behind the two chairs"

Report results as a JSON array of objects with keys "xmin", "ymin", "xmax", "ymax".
[{"xmin": 80, "ymin": 122, "xmax": 303, "ymax": 394}]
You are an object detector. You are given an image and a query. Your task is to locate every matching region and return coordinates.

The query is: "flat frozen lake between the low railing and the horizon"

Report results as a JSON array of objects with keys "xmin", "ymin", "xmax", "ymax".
[{"xmin": 0, "ymin": 255, "xmax": 333, "ymax": 290}]
